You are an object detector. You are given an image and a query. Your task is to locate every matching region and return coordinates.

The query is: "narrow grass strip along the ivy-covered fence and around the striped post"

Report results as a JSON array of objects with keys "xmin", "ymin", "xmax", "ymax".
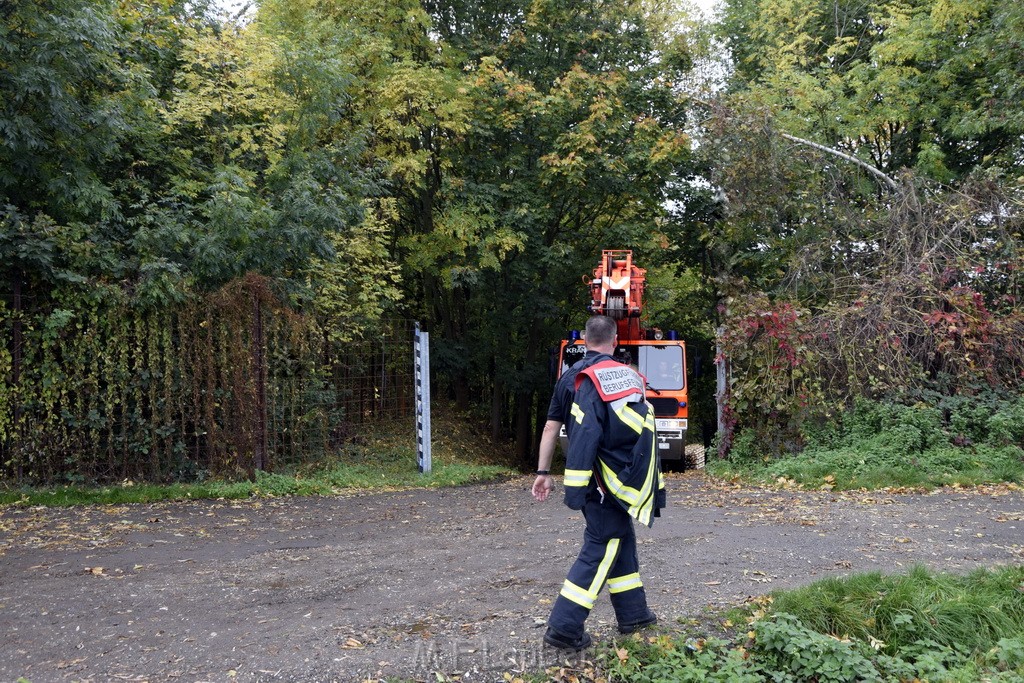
[{"xmin": 0, "ymin": 412, "xmax": 513, "ymax": 507}]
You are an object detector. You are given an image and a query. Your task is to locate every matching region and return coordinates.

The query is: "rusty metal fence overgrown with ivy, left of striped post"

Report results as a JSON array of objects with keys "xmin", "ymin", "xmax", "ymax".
[{"xmin": 0, "ymin": 275, "xmax": 414, "ymax": 483}]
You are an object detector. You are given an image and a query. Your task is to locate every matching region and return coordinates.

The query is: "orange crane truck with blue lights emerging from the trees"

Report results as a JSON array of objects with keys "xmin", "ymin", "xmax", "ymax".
[{"xmin": 558, "ymin": 249, "xmax": 688, "ymax": 469}]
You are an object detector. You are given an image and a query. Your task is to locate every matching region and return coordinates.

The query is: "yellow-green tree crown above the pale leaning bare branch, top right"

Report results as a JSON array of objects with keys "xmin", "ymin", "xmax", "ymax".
[{"xmin": 722, "ymin": 0, "xmax": 1024, "ymax": 180}]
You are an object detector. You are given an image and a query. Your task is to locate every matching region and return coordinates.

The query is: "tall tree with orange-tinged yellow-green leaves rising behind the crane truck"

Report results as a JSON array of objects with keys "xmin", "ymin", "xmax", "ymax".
[{"xmin": 404, "ymin": 1, "xmax": 689, "ymax": 462}]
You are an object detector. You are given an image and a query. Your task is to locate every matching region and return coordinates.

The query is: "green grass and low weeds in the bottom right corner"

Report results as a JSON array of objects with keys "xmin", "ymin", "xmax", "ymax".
[{"xmin": 598, "ymin": 566, "xmax": 1024, "ymax": 683}]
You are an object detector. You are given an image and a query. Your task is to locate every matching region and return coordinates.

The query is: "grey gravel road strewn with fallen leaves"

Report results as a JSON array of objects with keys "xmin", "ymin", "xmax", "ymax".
[{"xmin": 0, "ymin": 475, "xmax": 1024, "ymax": 683}]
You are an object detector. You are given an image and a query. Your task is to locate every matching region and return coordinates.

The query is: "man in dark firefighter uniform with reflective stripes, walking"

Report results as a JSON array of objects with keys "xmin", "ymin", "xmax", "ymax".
[{"xmin": 544, "ymin": 315, "xmax": 665, "ymax": 650}]
